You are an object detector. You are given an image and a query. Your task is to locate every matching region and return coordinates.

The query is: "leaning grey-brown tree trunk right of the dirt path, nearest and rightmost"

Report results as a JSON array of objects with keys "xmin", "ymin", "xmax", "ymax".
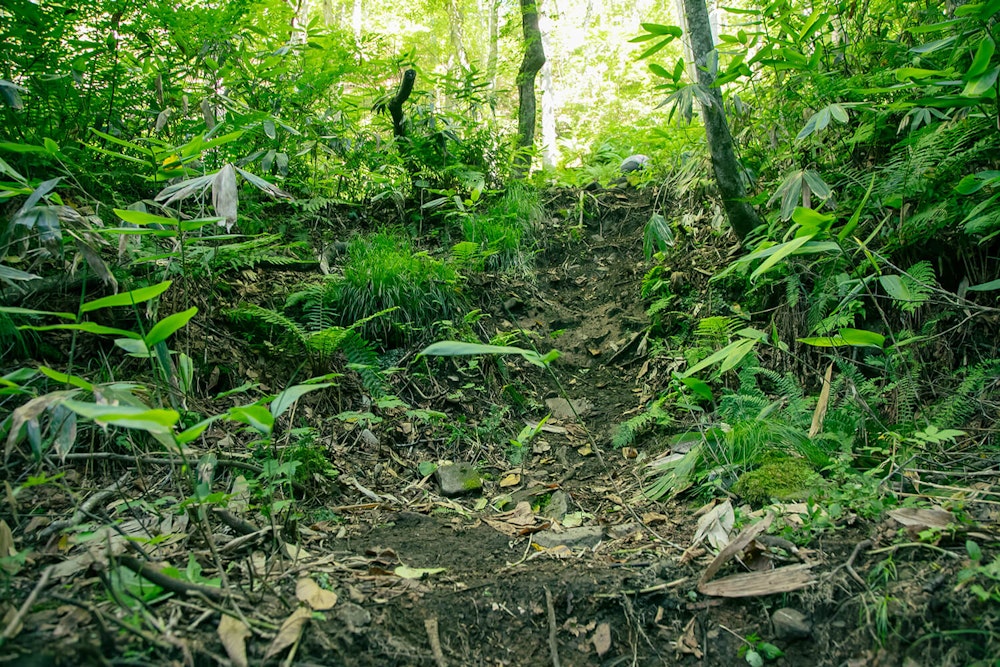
[{"xmin": 683, "ymin": 0, "xmax": 760, "ymax": 241}]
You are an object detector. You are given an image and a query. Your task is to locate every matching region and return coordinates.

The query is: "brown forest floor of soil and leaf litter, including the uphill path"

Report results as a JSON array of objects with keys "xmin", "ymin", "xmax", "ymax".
[{"xmin": 0, "ymin": 185, "xmax": 1000, "ymax": 667}]
